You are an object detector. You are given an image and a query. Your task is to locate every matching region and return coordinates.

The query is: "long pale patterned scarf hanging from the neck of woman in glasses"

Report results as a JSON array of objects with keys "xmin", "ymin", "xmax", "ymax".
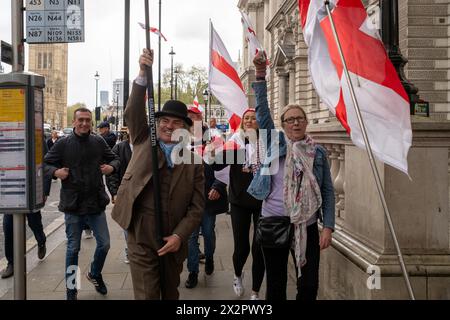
[{"xmin": 283, "ymin": 135, "xmax": 322, "ymax": 277}]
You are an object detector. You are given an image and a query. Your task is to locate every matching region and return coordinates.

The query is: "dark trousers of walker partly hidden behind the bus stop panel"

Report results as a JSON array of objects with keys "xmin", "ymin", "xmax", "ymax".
[{"xmin": 3, "ymin": 211, "xmax": 46, "ymax": 264}]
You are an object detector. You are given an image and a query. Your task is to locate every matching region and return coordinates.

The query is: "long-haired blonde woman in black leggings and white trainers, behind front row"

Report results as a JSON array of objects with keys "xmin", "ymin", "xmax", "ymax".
[{"xmin": 212, "ymin": 108, "xmax": 264, "ymax": 300}]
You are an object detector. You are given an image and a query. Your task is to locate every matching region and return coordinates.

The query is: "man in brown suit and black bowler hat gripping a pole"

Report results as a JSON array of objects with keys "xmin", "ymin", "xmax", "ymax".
[{"xmin": 112, "ymin": 49, "xmax": 205, "ymax": 300}]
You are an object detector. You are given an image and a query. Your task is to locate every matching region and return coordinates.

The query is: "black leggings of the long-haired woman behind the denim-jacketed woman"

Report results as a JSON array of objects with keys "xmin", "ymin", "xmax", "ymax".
[{"xmin": 231, "ymin": 204, "xmax": 265, "ymax": 292}]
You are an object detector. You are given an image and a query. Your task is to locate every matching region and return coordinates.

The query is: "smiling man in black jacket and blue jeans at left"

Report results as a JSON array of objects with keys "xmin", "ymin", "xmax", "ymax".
[{"xmin": 44, "ymin": 108, "xmax": 120, "ymax": 300}]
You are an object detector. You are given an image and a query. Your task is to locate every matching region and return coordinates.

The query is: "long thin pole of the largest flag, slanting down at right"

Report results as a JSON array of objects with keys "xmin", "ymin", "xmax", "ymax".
[{"xmin": 324, "ymin": 0, "xmax": 415, "ymax": 300}]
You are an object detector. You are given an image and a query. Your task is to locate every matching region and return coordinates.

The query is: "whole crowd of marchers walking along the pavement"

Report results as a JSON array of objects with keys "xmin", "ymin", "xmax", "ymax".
[{"xmin": 2, "ymin": 49, "xmax": 335, "ymax": 300}]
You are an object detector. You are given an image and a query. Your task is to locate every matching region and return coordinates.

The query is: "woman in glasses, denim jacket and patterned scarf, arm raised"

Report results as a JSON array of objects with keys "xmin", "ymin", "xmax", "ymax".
[{"xmin": 248, "ymin": 50, "xmax": 335, "ymax": 300}]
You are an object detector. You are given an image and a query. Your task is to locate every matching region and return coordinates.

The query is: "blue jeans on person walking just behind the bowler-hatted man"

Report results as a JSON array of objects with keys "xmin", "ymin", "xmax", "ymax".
[{"xmin": 187, "ymin": 212, "xmax": 216, "ymax": 273}]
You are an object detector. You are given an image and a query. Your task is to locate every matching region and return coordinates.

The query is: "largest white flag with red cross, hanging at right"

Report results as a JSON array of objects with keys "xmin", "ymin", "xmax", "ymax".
[{"xmin": 298, "ymin": 0, "xmax": 412, "ymax": 174}]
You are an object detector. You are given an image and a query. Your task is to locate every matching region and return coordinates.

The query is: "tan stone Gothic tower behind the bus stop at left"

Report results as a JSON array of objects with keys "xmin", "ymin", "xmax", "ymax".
[{"xmin": 28, "ymin": 43, "xmax": 68, "ymax": 129}]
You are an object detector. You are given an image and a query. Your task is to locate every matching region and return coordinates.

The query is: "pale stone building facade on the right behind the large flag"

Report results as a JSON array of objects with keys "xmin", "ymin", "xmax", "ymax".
[{"xmin": 237, "ymin": 0, "xmax": 450, "ymax": 299}]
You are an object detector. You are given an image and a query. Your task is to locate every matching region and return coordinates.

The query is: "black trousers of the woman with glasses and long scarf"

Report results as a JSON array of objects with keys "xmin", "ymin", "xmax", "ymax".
[{"xmin": 262, "ymin": 223, "xmax": 320, "ymax": 301}]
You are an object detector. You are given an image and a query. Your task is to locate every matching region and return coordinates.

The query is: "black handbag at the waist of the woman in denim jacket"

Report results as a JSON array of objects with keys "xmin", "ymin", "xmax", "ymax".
[{"xmin": 255, "ymin": 216, "xmax": 294, "ymax": 248}]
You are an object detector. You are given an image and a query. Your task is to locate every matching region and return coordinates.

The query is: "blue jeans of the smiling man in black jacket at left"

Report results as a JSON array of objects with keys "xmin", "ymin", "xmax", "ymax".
[{"xmin": 64, "ymin": 211, "xmax": 110, "ymax": 285}]
